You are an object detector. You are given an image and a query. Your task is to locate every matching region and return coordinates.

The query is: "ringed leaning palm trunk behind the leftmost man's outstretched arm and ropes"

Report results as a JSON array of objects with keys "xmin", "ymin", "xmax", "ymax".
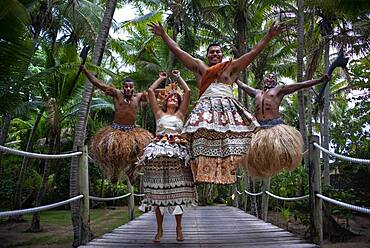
[{"xmin": 69, "ymin": 0, "xmax": 117, "ymax": 247}]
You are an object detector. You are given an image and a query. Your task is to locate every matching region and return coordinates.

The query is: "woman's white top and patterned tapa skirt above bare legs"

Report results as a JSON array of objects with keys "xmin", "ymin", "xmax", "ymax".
[{"xmin": 138, "ymin": 115, "xmax": 195, "ymax": 207}]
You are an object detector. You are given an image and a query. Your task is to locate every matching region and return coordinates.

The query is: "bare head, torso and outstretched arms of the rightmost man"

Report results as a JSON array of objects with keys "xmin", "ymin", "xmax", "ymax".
[{"xmin": 236, "ymin": 74, "xmax": 329, "ymax": 121}]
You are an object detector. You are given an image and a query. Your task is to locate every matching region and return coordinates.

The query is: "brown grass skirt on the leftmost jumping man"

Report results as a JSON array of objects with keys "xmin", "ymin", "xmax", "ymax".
[{"xmin": 90, "ymin": 126, "xmax": 153, "ymax": 182}]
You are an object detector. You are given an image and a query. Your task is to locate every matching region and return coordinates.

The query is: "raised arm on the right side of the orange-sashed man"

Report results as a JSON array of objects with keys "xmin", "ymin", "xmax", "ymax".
[{"xmin": 230, "ymin": 23, "xmax": 285, "ymax": 78}]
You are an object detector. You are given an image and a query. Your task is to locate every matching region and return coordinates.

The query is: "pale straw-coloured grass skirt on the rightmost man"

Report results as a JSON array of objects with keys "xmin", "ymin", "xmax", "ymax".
[{"xmin": 242, "ymin": 124, "xmax": 303, "ymax": 177}]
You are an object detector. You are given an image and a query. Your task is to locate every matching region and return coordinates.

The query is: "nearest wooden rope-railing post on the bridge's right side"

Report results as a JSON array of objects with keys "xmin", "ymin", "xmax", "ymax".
[{"xmin": 309, "ymin": 135, "xmax": 323, "ymax": 245}]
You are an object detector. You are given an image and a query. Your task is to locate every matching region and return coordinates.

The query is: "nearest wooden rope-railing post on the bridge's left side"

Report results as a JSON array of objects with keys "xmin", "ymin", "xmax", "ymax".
[{"xmin": 79, "ymin": 145, "xmax": 91, "ymax": 245}]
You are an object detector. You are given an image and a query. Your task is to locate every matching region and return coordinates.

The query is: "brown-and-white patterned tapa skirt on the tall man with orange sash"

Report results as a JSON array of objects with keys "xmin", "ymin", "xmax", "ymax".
[{"xmin": 183, "ymin": 81, "xmax": 259, "ymax": 184}]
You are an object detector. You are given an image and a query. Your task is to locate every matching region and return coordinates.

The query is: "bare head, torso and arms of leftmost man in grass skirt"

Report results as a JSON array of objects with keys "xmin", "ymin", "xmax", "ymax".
[{"xmin": 81, "ymin": 65, "xmax": 145, "ymax": 125}]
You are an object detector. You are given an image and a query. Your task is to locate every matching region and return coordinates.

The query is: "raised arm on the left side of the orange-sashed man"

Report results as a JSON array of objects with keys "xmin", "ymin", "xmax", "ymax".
[{"xmin": 148, "ymin": 22, "xmax": 206, "ymax": 75}]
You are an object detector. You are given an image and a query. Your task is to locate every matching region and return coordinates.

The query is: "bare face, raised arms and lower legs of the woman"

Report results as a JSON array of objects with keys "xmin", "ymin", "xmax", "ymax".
[{"xmin": 148, "ymin": 70, "xmax": 190, "ymax": 243}]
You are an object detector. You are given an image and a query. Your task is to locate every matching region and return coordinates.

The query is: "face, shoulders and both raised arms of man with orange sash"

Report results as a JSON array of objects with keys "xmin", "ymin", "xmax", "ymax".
[{"xmin": 149, "ymin": 23, "xmax": 285, "ymax": 86}]
